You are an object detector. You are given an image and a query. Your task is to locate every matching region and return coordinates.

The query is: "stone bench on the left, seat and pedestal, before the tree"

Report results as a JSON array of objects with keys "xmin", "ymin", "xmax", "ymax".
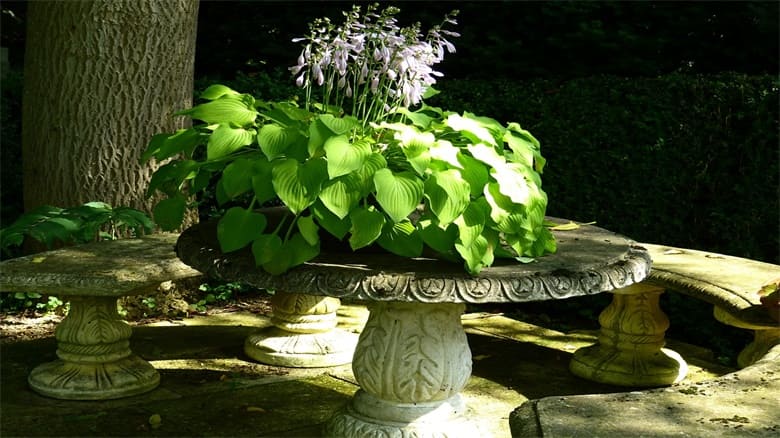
[{"xmin": 0, "ymin": 233, "xmax": 200, "ymax": 400}]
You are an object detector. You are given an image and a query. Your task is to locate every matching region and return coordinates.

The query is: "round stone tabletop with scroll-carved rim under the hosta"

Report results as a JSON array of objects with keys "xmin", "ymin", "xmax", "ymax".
[{"xmin": 176, "ymin": 218, "xmax": 651, "ymax": 303}]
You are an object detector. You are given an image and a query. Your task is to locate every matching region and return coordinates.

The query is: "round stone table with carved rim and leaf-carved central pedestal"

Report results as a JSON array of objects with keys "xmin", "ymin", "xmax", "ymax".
[{"xmin": 176, "ymin": 218, "xmax": 651, "ymax": 437}]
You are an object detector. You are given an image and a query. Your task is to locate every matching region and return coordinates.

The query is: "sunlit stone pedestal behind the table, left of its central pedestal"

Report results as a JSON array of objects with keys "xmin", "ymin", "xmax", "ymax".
[{"xmin": 244, "ymin": 292, "xmax": 358, "ymax": 368}]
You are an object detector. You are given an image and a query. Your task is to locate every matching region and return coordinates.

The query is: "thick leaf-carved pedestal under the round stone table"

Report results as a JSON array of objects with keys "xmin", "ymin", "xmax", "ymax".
[{"xmin": 325, "ymin": 302, "xmax": 480, "ymax": 437}]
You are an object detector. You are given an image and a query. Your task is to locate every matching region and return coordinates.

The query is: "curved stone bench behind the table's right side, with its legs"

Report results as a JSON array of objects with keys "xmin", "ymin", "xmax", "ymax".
[{"xmin": 570, "ymin": 244, "xmax": 780, "ymax": 387}]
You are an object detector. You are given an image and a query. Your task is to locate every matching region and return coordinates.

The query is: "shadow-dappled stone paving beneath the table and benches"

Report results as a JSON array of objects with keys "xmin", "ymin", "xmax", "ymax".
[{"xmin": 0, "ymin": 306, "xmax": 733, "ymax": 437}]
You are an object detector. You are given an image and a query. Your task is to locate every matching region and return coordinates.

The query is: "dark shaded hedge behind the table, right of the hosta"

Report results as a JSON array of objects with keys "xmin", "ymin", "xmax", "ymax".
[{"xmin": 430, "ymin": 73, "xmax": 780, "ymax": 263}]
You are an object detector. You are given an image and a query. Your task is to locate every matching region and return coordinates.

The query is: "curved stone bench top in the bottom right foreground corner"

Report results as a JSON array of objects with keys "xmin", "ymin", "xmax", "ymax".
[{"xmin": 510, "ymin": 345, "xmax": 780, "ymax": 438}]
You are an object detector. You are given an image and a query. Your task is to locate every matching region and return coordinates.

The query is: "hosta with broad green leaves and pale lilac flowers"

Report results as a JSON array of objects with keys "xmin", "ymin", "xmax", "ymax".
[{"xmin": 143, "ymin": 6, "xmax": 555, "ymax": 275}]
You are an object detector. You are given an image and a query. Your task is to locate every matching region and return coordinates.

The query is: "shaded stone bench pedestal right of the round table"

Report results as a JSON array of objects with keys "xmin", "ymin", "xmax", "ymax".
[{"xmin": 569, "ymin": 283, "xmax": 688, "ymax": 387}]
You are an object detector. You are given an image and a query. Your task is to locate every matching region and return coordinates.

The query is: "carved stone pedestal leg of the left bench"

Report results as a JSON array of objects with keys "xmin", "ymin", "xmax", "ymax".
[{"xmin": 28, "ymin": 297, "xmax": 160, "ymax": 400}]
